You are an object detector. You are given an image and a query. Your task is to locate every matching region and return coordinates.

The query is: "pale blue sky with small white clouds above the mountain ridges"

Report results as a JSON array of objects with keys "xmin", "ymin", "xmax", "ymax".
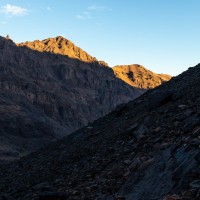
[{"xmin": 0, "ymin": 0, "xmax": 200, "ymax": 75}]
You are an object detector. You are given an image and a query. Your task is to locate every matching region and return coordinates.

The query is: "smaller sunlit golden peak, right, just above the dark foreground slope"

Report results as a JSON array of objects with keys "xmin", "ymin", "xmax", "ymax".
[{"xmin": 112, "ymin": 65, "xmax": 172, "ymax": 89}]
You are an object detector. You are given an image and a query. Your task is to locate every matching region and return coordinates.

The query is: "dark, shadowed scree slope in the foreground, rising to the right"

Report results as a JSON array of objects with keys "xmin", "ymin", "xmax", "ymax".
[{"xmin": 0, "ymin": 65, "xmax": 200, "ymax": 200}]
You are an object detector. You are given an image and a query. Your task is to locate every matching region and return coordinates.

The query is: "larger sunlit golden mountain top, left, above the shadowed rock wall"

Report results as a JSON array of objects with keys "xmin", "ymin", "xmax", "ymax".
[{"xmin": 17, "ymin": 36, "xmax": 108, "ymax": 66}]
